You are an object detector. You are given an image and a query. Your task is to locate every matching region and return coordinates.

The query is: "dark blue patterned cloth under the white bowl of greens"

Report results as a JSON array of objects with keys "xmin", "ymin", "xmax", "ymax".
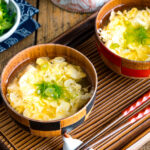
[{"xmin": 0, "ymin": 0, "xmax": 40, "ymax": 52}]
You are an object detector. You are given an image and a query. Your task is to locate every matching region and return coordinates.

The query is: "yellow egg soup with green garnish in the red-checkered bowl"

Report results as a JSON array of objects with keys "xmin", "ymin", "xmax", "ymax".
[{"xmin": 98, "ymin": 8, "xmax": 150, "ymax": 61}]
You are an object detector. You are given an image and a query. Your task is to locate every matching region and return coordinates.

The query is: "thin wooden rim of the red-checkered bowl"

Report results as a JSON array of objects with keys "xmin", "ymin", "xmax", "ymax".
[{"xmin": 95, "ymin": 0, "xmax": 150, "ymax": 64}]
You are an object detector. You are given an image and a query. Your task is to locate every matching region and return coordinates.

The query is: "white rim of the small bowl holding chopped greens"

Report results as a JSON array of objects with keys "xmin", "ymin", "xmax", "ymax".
[{"xmin": 0, "ymin": 0, "xmax": 21, "ymax": 42}]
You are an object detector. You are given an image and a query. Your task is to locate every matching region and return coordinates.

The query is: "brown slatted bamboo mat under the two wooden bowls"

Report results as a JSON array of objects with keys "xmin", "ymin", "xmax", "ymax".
[{"xmin": 0, "ymin": 37, "xmax": 150, "ymax": 150}]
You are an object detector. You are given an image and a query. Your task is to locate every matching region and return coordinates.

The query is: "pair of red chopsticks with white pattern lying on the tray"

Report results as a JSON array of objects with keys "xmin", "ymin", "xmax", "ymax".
[{"xmin": 76, "ymin": 91, "xmax": 150, "ymax": 150}]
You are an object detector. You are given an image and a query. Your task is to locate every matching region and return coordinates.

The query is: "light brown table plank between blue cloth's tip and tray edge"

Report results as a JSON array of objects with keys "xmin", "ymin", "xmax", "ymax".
[{"xmin": 37, "ymin": 0, "xmax": 90, "ymax": 43}]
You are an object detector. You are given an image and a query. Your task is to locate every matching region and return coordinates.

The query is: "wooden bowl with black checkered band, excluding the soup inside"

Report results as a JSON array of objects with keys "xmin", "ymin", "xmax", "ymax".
[{"xmin": 1, "ymin": 44, "xmax": 97, "ymax": 137}]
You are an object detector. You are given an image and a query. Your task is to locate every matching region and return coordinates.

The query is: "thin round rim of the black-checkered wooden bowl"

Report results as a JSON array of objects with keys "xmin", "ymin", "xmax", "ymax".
[{"xmin": 0, "ymin": 43, "xmax": 98, "ymax": 123}]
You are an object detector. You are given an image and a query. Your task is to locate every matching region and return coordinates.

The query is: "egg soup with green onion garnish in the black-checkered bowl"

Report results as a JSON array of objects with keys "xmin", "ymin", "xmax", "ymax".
[{"xmin": 7, "ymin": 57, "xmax": 92, "ymax": 120}]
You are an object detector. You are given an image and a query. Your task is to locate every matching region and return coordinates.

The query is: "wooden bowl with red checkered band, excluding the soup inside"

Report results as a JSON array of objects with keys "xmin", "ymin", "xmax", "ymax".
[{"xmin": 95, "ymin": 0, "xmax": 150, "ymax": 79}]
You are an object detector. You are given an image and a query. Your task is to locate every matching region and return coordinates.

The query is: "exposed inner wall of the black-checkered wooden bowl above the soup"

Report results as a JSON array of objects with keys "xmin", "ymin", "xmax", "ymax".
[{"xmin": 1, "ymin": 44, "xmax": 97, "ymax": 122}]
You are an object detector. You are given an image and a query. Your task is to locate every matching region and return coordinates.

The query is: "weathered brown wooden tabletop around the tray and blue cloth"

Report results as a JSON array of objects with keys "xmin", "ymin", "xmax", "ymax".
[{"xmin": 0, "ymin": 0, "xmax": 150, "ymax": 150}]
